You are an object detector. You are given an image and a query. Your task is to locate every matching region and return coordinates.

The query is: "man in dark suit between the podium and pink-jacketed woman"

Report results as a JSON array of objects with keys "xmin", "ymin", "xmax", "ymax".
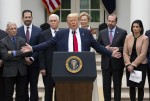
[{"xmin": 97, "ymin": 14, "xmax": 127, "ymax": 101}]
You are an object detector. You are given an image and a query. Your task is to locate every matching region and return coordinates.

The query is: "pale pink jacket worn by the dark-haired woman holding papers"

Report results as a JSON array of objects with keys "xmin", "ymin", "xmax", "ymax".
[{"xmin": 123, "ymin": 33, "xmax": 149, "ymax": 67}]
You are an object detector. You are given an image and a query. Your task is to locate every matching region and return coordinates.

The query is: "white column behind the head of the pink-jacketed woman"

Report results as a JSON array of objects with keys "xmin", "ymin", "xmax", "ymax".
[{"xmin": 130, "ymin": 0, "xmax": 150, "ymax": 31}]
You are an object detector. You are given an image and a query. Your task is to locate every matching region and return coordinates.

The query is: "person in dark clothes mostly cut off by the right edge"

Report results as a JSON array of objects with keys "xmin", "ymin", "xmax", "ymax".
[{"xmin": 145, "ymin": 30, "xmax": 150, "ymax": 99}]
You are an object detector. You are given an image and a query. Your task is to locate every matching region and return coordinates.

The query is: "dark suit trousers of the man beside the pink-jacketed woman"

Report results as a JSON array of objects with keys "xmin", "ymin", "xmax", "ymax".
[{"xmin": 102, "ymin": 70, "xmax": 123, "ymax": 101}]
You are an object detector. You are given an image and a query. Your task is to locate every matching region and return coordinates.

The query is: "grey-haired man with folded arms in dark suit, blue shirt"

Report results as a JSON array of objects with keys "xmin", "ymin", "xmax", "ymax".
[{"xmin": 0, "ymin": 22, "xmax": 27, "ymax": 101}]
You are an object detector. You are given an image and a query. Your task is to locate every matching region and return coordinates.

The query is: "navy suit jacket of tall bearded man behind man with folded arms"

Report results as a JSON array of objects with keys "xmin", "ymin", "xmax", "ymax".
[{"xmin": 17, "ymin": 25, "xmax": 41, "ymax": 60}]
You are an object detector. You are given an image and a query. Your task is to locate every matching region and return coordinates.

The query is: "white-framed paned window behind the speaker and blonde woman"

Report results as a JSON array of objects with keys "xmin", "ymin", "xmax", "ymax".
[{"xmin": 55, "ymin": 0, "xmax": 104, "ymax": 28}]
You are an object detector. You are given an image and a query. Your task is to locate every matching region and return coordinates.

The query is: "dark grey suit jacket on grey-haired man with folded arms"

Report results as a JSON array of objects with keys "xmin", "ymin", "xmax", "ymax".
[{"xmin": 0, "ymin": 36, "xmax": 27, "ymax": 77}]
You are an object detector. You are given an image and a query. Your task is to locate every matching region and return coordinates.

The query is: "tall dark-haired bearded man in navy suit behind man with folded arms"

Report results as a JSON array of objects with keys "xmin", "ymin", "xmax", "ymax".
[{"xmin": 17, "ymin": 10, "xmax": 41, "ymax": 101}]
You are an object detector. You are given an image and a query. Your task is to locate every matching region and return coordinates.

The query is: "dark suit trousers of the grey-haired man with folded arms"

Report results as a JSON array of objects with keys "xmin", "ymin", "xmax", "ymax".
[{"xmin": 4, "ymin": 73, "xmax": 27, "ymax": 101}]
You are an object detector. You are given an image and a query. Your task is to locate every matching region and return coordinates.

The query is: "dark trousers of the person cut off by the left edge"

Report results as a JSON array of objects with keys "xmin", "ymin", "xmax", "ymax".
[{"xmin": 0, "ymin": 67, "xmax": 4, "ymax": 101}]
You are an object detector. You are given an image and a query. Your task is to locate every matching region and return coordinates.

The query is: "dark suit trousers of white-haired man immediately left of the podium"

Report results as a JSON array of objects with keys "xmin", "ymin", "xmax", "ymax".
[{"xmin": 43, "ymin": 73, "xmax": 55, "ymax": 101}]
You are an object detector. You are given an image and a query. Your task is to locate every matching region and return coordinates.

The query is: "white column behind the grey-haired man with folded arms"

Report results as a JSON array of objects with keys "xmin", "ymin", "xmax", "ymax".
[{"xmin": 0, "ymin": 0, "xmax": 21, "ymax": 30}]
